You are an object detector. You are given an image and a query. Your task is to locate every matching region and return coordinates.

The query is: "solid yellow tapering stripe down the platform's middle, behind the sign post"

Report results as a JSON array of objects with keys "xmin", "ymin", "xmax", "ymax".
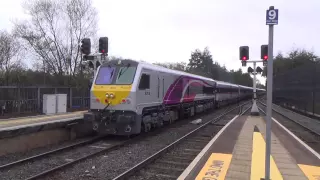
[{"xmin": 251, "ymin": 132, "xmax": 283, "ymax": 180}]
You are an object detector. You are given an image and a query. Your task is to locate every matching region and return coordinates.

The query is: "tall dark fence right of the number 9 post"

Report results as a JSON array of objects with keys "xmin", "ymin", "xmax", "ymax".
[{"xmin": 273, "ymin": 62, "xmax": 320, "ymax": 116}]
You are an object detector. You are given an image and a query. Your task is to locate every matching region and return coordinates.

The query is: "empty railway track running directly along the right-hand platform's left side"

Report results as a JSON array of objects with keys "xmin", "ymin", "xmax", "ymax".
[{"xmin": 114, "ymin": 105, "xmax": 251, "ymax": 180}]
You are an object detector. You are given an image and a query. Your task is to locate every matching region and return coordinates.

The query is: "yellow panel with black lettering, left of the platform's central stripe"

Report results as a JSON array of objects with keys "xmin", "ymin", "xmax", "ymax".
[{"xmin": 196, "ymin": 153, "xmax": 232, "ymax": 180}]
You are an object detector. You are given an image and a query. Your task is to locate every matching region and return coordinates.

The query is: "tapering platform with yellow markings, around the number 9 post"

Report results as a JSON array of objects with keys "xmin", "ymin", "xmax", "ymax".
[{"xmin": 178, "ymin": 116, "xmax": 320, "ymax": 180}]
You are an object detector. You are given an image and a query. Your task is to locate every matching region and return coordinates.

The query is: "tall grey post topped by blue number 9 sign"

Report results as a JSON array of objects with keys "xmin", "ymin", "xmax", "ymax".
[{"xmin": 265, "ymin": 6, "xmax": 279, "ymax": 180}]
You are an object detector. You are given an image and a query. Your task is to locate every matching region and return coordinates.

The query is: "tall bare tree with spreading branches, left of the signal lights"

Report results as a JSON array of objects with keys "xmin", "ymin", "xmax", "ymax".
[{"xmin": 15, "ymin": 0, "xmax": 98, "ymax": 82}]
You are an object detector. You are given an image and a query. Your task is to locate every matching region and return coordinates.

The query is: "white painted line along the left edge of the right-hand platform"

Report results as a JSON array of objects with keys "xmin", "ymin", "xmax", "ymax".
[{"xmin": 178, "ymin": 115, "xmax": 239, "ymax": 180}]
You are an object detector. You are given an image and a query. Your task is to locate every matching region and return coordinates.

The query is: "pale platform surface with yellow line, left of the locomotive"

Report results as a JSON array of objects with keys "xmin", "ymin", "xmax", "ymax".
[{"xmin": 0, "ymin": 111, "xmax": 87, "ymax": 131}]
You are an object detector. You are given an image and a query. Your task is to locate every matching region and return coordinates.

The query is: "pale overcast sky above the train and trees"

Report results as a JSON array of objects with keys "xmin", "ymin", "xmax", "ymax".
[{"xmin": 0, "ymin": 0, "xmax": 320, "ymax": 84}]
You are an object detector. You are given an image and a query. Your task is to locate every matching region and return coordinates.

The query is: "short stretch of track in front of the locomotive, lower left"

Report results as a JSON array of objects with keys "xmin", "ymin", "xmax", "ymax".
[{"xmin": 0, "ymin": 137, "xmax": 129, "ymax": 180}]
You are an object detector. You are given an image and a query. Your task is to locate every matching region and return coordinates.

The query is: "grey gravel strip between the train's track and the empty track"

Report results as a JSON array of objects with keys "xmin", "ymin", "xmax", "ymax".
[{"xmin": 42, "ymin": 103, "xmax": 242, "ymax": 180}]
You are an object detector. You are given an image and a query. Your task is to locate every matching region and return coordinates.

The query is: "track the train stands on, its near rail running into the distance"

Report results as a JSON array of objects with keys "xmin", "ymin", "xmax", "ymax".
[{"xmin": 0, "ymin": 101, "xmax": 250, "ymax": 180}]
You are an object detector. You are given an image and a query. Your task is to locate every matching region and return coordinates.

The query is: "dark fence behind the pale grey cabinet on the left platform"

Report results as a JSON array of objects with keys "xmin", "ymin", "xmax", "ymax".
[{"xmin": 0, "ymin": 86, "xmax": 90, "ymax": 118}]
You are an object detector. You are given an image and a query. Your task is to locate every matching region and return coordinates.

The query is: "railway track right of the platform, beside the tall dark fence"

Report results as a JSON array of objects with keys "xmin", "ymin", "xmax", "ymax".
[{"xmin": 258, "ymin": 102, "xmax": 320, "ymax": 152}]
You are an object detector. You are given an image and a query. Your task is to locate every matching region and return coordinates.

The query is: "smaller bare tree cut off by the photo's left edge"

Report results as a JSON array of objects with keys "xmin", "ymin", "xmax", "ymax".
[{"xmin": 0, "ymin": 31, "xmax": 23, "ymax": 85}]
